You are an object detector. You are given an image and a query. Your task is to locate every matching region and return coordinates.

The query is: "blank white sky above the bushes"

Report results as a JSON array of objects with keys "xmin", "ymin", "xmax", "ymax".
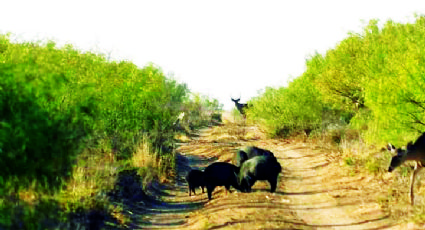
[{"xmin": 0, "ymin": 0, "xmax": 425, "ymax": 109}]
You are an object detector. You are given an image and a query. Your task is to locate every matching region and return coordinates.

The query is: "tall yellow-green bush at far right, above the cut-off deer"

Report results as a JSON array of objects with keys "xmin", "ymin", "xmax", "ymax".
[{"xmin": 307, "ymin": 17, "xmax": 425, "ymax": 144}]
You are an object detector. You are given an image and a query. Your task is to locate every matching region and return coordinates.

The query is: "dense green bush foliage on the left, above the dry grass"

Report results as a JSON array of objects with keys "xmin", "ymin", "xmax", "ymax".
[{"xmin": 0, "ymin": 33, "xmax": 188, "ymax": 188}]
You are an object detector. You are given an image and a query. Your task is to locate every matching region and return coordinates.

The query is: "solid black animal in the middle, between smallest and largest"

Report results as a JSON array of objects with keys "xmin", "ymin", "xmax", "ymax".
[{"xmin": 204, "ymin": 162, "xmax": 240, "ymax": 200}]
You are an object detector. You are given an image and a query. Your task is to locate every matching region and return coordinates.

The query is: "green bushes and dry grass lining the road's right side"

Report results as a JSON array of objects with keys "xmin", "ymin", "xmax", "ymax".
[{"xmin": 248, "ymin": 16, "xmax": 425, "ymax": 222}]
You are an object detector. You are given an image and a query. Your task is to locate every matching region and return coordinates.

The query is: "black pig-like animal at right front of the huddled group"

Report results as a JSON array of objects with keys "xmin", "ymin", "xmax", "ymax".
[{"xmin": 238, "ymin": 156, "xmax": 282, "ymax": 192}]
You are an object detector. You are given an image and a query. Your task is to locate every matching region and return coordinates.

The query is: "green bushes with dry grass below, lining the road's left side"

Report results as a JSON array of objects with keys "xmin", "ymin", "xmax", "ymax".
[{"xmin": 0, "ymin": 35, "xmax": 222, "ymax": 229}]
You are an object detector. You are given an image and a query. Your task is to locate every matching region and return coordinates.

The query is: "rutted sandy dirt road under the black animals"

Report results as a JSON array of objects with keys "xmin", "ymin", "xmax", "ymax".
[{"xmin": 136, "ymin": 117, "xmax": 414, "ymax": 229}]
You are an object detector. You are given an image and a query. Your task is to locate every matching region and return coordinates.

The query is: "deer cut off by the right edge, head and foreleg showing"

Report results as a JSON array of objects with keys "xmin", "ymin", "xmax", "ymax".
[{"xmin": 387, "ymin": 133, "xmax": 425, "ymax": 205}]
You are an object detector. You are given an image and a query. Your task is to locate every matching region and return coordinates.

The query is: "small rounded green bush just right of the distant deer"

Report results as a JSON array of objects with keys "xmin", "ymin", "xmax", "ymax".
[{"xmin": 248, "ymin": 73, "xmax": 323, "ymax": 136}]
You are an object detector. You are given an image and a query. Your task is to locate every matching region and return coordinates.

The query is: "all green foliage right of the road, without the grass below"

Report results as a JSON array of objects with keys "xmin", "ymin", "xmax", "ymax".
[{"xmin": 251, "ymin": 16, "xmax": 425, "ymax": 145}]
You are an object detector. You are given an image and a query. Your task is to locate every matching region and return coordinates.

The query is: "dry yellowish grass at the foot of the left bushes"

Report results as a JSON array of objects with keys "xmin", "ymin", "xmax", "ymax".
[{"xmin": 60, "ymin": 137, "xmax": 166, "ymax": 227}]
